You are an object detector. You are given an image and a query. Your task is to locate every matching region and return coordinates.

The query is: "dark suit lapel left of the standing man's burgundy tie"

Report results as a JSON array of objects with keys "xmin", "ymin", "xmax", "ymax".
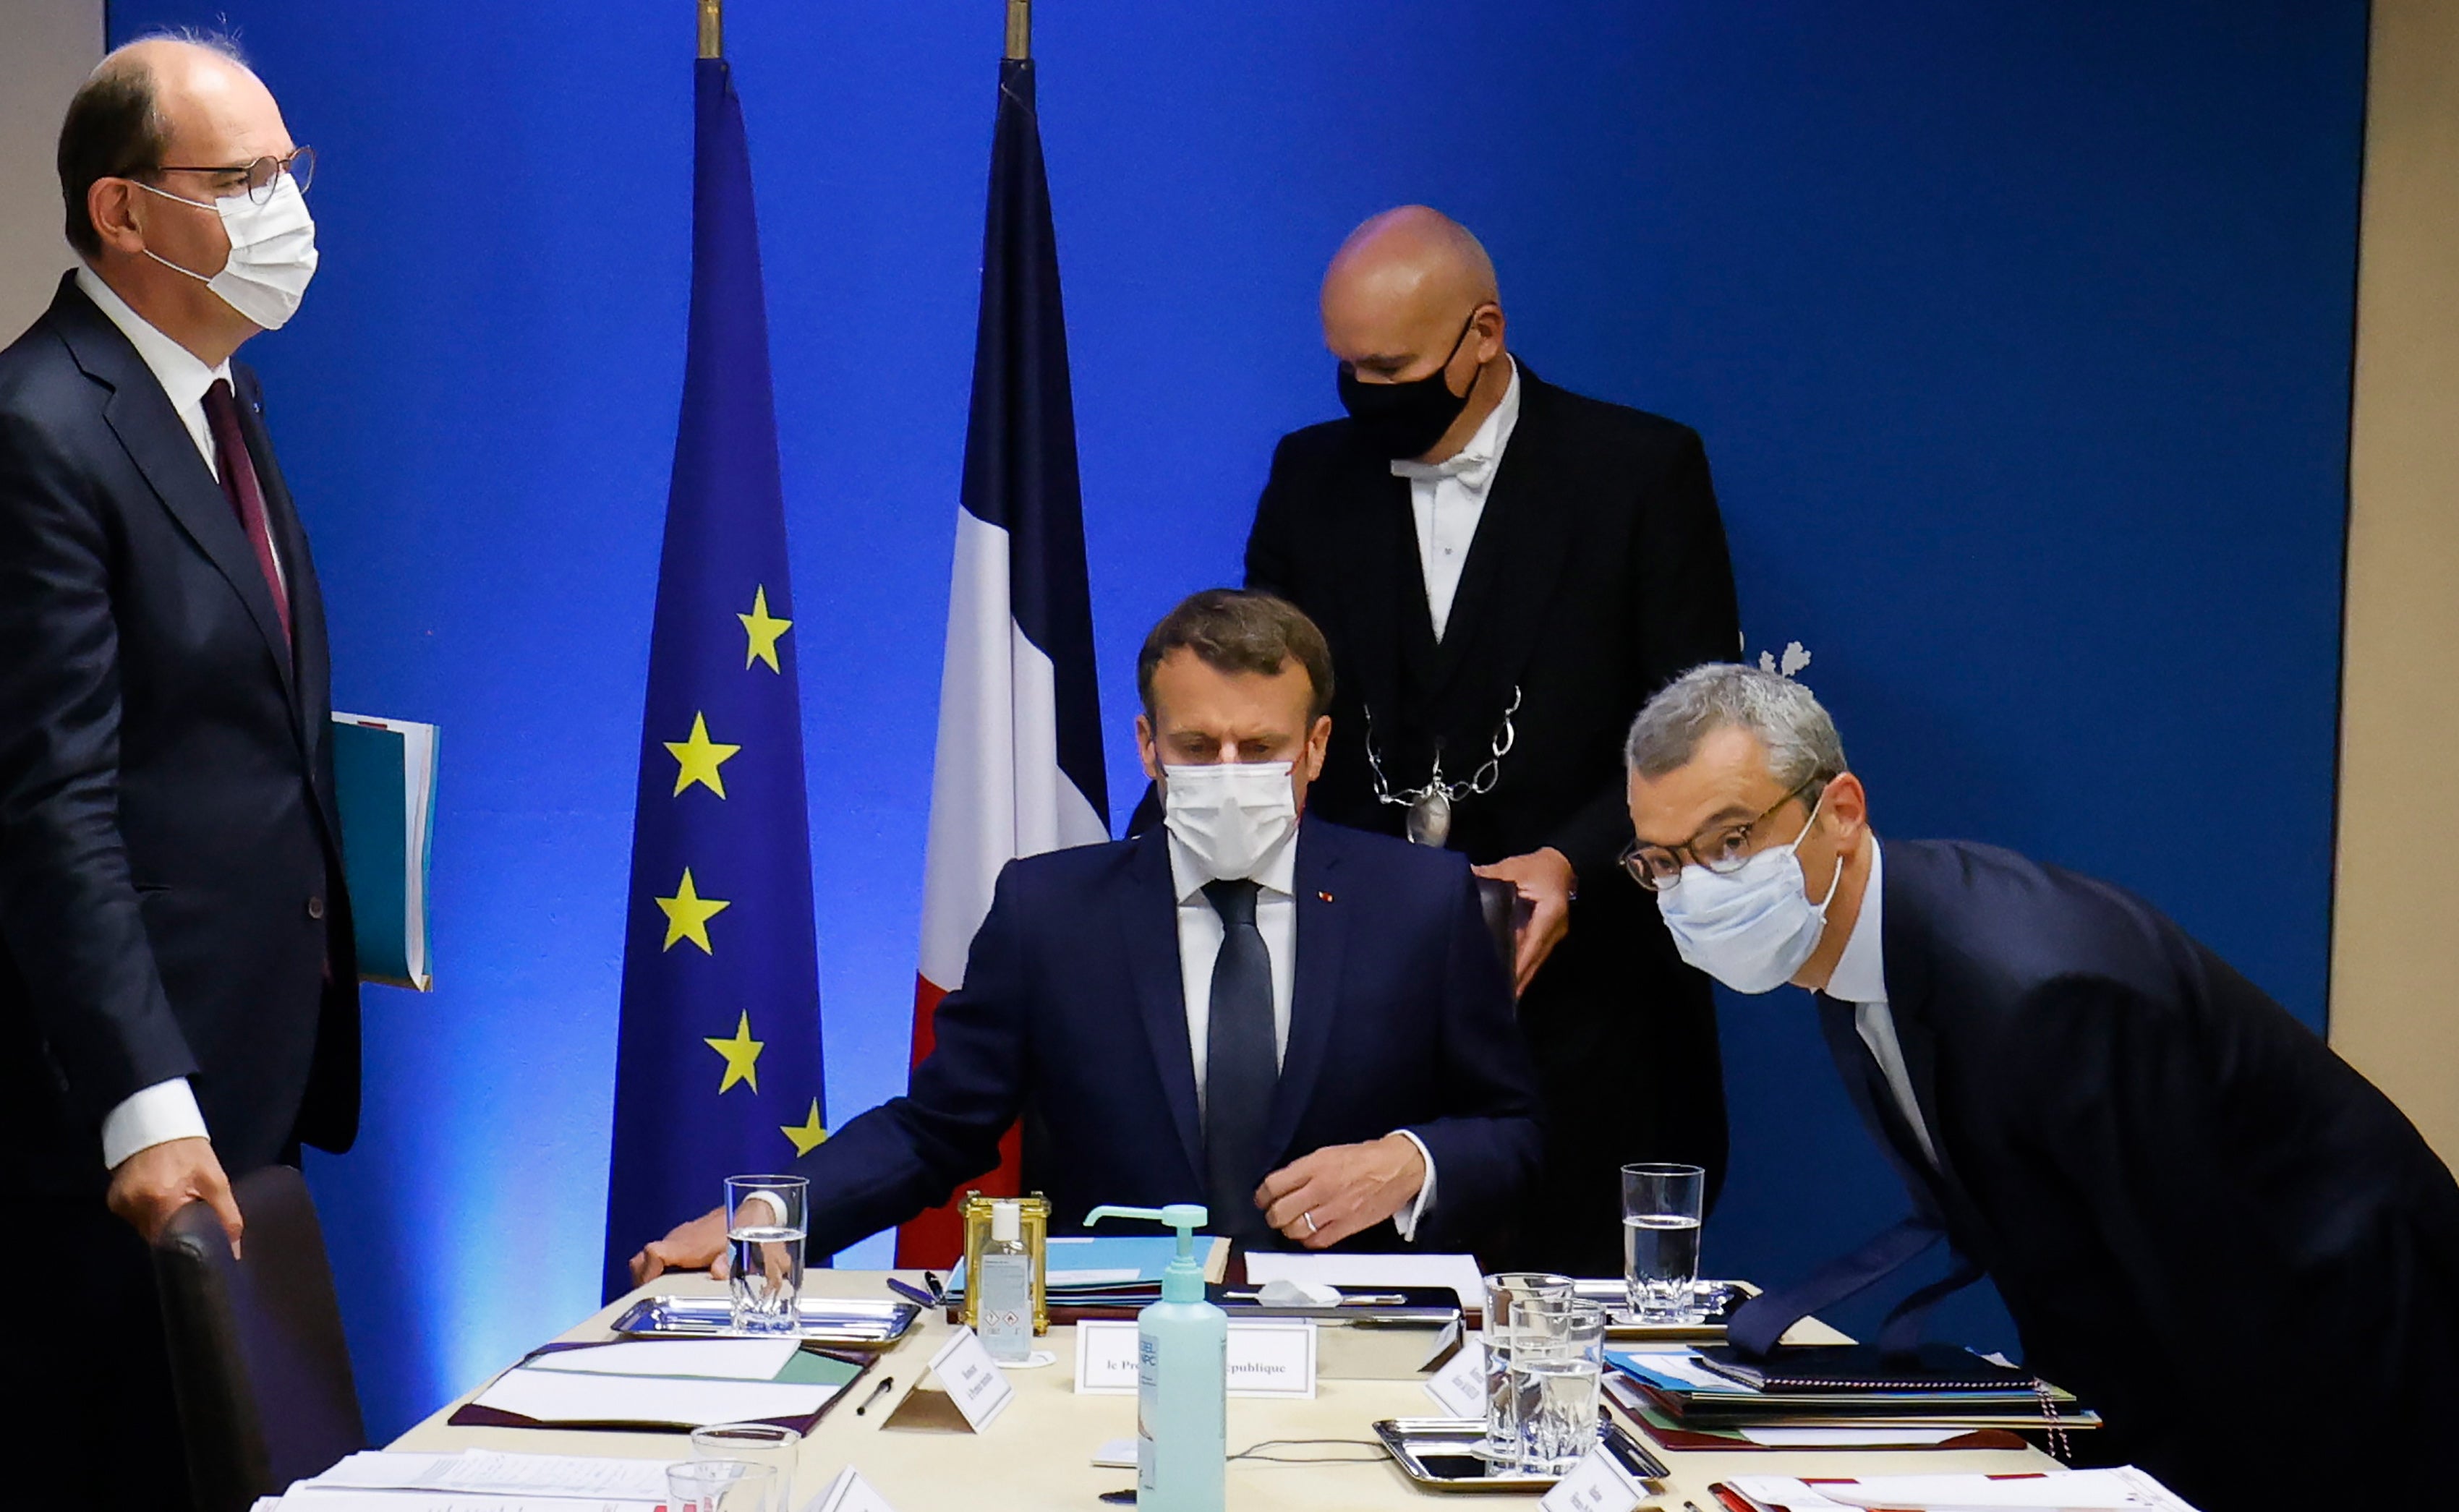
[{"xmin": 51, "ymin": 283, "xmax": 297, "ymax": 699}]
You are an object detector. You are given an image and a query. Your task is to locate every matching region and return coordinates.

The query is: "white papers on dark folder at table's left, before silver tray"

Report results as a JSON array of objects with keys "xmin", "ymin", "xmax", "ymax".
[{"xmin": 453, "ymin": 1338, "xmax": 863, "ymax": 1431}]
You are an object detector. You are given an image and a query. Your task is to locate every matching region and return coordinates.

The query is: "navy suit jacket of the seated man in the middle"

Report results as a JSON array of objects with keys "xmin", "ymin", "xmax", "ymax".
[{"xmin": 797, "ymin": 819, "xmax": 1539, "ymax": 1254}]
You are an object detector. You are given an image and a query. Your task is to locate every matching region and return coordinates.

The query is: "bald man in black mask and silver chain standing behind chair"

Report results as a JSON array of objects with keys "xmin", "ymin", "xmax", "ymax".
[{"xmin": 1247, "ymin": 207, "xmax": 1741, "ymax": 1276}]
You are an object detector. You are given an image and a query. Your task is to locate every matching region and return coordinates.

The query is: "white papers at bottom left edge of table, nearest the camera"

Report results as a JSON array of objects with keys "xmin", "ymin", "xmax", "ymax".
[{"xmin": 256, "ymin": 1448, "xmax": 669, "ymax": 1512}]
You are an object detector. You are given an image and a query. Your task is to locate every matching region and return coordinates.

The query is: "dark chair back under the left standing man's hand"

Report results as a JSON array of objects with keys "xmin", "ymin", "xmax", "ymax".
[{"xmin": 153, "ymin": 1166, "xmax": 367, "ymax": 1512}]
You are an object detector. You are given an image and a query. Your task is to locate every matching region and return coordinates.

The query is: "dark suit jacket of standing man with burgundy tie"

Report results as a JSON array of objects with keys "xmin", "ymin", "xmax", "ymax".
[{"xmin": 0, "ymin": 278, "xmax": 359, "ymax": 1192}]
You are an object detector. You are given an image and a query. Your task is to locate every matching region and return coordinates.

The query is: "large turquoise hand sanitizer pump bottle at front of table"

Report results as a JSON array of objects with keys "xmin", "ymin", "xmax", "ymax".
[{"xmin": 1084, "ymin": 1203, "xmax": 1230, "ymax": 1512}]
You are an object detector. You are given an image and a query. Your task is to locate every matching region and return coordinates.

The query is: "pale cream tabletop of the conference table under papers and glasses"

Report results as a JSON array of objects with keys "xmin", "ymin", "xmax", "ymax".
[{"xmin": 391, "ymin": 1271, "xmax": 2055, "ymax": 1512}]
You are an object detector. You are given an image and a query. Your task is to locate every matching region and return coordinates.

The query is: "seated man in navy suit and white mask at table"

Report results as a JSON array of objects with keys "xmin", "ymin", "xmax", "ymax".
[{"xmin": 632, "ymin": 590, "xmax": 1539, "ymax": 1281}]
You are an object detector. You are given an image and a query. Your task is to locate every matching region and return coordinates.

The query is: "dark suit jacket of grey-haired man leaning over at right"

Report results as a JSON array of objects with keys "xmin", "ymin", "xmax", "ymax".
[{"xmin": 1832, "ymin": 841, "xmax": 2459, "ymax": 1512}]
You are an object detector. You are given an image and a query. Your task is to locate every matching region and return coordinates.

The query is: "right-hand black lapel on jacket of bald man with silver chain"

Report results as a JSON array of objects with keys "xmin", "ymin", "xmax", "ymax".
[{"xmin": 1428, "ymin": 371, "xmax": 1576, "ymax": 715}]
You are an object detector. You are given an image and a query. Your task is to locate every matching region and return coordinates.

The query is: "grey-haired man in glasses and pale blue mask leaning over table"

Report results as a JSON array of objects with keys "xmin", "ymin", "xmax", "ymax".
[{"xmin": 1623, "ymin": 666, "xmax": 2459, "ymax": 1512}]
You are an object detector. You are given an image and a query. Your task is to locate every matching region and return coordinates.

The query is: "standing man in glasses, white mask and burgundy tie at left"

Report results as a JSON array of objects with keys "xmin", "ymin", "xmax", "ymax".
[{"xmin": 0, "ymin": 39, "xmax": 359, "ymax": 1507}]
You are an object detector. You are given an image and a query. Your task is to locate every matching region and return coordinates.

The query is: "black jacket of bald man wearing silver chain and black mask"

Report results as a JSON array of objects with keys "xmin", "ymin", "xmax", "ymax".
[{"xmin": 1247, "ymin": 364, "xmax": 1741, "ymax": 887}]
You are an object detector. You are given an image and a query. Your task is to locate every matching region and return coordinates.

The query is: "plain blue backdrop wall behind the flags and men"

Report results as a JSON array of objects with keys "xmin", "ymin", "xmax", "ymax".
[{"xmin": 113, "ymin": 0, "xmax": 2366, "ymax": 1433}]
